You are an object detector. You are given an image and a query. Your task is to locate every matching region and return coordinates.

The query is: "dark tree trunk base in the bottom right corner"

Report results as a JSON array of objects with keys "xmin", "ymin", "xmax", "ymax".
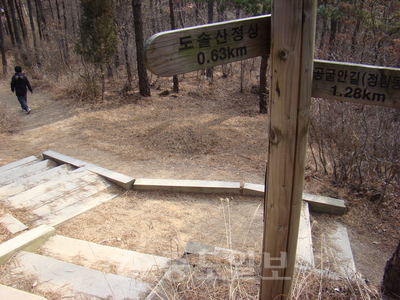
[{"xmin": 381, "ymin": 241, "xmax": 400, "ymax": 299}]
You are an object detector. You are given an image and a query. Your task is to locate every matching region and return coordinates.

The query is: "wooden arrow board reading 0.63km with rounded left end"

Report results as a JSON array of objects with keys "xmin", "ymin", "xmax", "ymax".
[{"xmin": 144, "ymin": 15, "xmax": 271, "ymax": 77}]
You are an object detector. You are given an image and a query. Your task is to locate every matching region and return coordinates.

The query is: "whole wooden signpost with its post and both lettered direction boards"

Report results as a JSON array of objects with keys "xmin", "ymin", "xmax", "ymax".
[{"xmin": 145, "ymin": 0, "xmax": 400, "ymax": 300}]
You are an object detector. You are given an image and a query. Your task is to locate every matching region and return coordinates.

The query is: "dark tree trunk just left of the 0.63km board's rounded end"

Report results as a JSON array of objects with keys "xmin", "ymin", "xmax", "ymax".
[{"xmin": 132, "ymin": 0, "xmax": 150, "ymax": 97}]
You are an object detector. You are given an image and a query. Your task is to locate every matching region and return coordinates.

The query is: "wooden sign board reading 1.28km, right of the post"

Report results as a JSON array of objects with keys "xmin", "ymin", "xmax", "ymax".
[{"xmin": 312, "ymin": 60, "xmax": 400, "ymax": 108}]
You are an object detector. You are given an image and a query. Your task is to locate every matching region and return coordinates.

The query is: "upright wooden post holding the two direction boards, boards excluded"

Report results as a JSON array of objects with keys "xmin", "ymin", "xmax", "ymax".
[{"xmin": 260, "ymin": 0, "xmax": 316, "ymax": 300}]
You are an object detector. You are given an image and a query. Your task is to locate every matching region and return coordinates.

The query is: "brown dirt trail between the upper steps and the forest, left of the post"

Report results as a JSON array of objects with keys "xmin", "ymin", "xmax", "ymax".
[{"xmin": 0, "ymin": 78, "xmax": 266, "ymax": 183}]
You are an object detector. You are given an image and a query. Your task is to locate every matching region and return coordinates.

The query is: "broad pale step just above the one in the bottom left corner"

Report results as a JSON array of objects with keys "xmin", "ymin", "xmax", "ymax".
[{"xmin": 8, "ymin": 251, "xmax": 149, "ymax": 300}]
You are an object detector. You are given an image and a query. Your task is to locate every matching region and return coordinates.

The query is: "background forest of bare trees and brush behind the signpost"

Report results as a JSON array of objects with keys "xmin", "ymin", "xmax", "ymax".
[{"xmin": 0, "ymin": 0, "xmax": 400, "ymax": 236}]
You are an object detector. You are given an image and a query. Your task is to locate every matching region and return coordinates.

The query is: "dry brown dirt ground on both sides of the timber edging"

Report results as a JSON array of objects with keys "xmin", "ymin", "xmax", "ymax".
[{"xmin": 0, "ymin": 73, "xmax": 400, "ymax": 298}]
